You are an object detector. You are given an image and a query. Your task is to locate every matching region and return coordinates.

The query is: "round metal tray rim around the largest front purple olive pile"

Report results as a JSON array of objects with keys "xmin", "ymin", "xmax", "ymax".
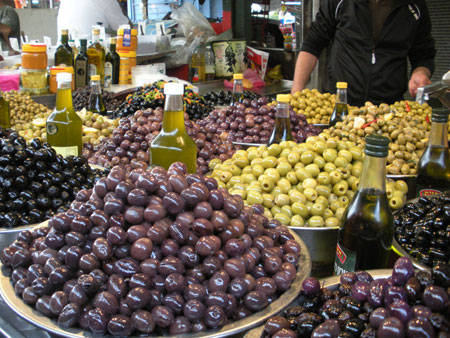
[{"xmin": 0, "ymin": 225, "xmax": 311, "ymax": 338}]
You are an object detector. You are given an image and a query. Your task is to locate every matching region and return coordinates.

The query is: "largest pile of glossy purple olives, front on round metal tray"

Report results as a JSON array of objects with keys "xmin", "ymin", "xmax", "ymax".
[{"xmin": 0, "ymin": 163, "xmax": 301, "ymax": 336}]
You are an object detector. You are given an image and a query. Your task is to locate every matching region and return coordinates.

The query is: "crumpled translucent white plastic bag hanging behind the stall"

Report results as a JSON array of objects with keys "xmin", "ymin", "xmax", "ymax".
[{"xmin": 171, "ymin": 2, "xmax": 216, "ymax": 44}]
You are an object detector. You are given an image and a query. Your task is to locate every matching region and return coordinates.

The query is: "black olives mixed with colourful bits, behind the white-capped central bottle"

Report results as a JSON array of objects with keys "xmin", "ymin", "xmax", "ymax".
[{"xmin": 108, "ymin": 81, "xmax": 214, "ymax": 120}]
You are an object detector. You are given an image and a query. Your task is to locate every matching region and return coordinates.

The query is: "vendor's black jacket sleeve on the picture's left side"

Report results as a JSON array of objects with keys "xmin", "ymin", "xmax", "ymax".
[{"xmin": 301, "ymin": 0, "xmax": 342, "ymax": 58}]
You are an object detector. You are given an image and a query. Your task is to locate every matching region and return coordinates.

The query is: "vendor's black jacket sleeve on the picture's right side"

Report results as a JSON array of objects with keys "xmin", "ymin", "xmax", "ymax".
[{"xmin": 408, "ymin": 2, "xmax": 436, "ymax": 74}]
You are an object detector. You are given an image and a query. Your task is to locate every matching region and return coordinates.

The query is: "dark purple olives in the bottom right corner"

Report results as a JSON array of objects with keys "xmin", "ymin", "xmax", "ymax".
[{"xmin": 264, "ymin": 257, "xmax": 450, "ymax": 338}]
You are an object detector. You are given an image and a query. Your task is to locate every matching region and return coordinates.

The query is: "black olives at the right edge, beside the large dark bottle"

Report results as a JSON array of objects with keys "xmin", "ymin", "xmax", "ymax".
[{"xmin": 394, "ymin": 192, "xmax": 450, "ymax": 267}]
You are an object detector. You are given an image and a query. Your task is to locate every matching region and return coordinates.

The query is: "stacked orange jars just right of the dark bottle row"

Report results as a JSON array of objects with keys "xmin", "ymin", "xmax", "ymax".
[{"xmin": 116, "ymin": 28, "xmax": 137, "ymax": 84}]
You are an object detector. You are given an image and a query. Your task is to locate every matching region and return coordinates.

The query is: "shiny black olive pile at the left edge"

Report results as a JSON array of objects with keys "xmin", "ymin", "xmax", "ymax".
[{"xmin": 0, "ymin": 130, "xmax": 104, "ymax": 227}]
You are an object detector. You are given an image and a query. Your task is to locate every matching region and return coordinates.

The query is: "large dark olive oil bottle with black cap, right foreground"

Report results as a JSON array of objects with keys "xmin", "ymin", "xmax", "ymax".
[{"xmin": 334, "ymin": 134, "xmax": 394, "ymax": 275}]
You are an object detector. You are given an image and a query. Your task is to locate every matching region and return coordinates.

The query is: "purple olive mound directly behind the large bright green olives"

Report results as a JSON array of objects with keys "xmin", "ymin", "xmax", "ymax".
[{"xmin": 197, "ymin": 97, "xmax": 321, "ymax": 144}]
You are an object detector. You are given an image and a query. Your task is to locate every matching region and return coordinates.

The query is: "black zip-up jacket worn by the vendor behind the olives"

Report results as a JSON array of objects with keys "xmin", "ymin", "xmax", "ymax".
[{"xmin": 302, "ymin": 0, "xmax": 436, "ymax": 106}]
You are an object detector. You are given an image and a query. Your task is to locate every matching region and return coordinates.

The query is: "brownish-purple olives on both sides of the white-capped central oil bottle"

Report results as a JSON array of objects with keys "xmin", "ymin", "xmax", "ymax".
[{"xmin": 83, "ymin": 108, "xmax": 236, "ymax": 175}]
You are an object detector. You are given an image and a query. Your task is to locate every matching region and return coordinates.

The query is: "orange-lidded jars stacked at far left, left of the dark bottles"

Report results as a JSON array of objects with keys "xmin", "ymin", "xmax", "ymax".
[{"xmin": 20, "ymin": 44, "xmax": 48, "ymax": 95}]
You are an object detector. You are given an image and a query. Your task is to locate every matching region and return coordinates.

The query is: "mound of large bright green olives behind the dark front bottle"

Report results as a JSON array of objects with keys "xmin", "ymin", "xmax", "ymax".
[{"xmin": 209, "ymin": 134, "xmax": 408, "ymax": 227}]
